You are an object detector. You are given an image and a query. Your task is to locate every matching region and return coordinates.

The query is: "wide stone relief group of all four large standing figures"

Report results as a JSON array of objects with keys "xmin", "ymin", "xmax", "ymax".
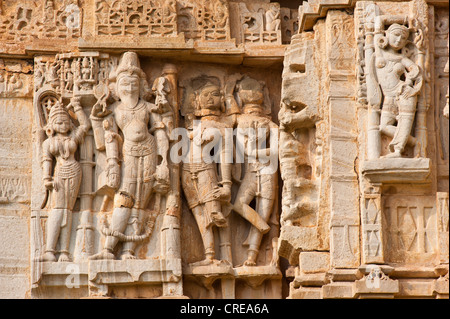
[{"xmin": 26, "ymin": 48, "xmax": 280, "ymax": 297}]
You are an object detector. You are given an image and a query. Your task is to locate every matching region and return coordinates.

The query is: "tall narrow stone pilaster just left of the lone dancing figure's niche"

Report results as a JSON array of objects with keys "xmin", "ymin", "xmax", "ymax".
[{"xmin": 326, "ymin": 11, "xmax": 360, "ymax": 268}]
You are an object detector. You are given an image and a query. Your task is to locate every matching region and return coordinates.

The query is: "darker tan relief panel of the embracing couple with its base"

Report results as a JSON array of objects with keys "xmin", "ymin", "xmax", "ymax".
[{"xmin": 180, "ymin": 69, "xmax": 280, "ymax": 298}]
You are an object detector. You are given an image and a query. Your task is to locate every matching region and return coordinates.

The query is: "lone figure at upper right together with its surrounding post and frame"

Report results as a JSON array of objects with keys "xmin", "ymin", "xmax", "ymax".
[{"xmin": 365, "ymin": 5, "xmax": 426, "ymax": 159}]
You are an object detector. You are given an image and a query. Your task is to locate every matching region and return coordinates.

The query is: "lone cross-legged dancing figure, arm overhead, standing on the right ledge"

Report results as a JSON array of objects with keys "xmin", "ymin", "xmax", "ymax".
[{"xmin": 368, "ymin": 16, "xmax": 423, "ymax": 157}]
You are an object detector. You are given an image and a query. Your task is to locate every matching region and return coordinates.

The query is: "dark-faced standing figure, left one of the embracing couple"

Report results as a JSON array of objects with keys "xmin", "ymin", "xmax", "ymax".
[{"xmin": 181, "ymin": 79, "xmax": 233, "ymax": 266}]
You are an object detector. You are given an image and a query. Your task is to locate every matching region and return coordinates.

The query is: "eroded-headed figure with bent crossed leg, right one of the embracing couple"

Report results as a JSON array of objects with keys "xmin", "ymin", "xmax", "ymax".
[{"xmin": 233, "ymin": 77, "xmax": 278, "ymax": 266}]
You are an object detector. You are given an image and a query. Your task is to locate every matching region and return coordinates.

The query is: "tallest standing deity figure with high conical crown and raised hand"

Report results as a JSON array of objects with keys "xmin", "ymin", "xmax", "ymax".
[{"xmin": 91, "ymin": 52, "xmax": 169, "ymax": 260}]
